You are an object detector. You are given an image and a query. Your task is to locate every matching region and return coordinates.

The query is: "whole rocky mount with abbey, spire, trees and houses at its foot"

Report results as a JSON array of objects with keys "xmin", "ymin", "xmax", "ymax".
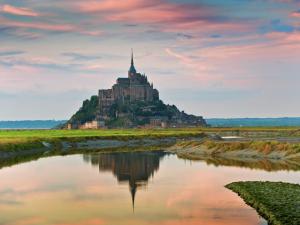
[{"xmin": 65, "ymin": 52, "xmax": 206, "ymax": 129}]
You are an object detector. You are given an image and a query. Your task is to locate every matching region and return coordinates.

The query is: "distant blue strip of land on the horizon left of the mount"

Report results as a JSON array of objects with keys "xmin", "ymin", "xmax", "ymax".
[{"xmin": 0, "ymin": 120, "xmax": 66, "ymax": 129}]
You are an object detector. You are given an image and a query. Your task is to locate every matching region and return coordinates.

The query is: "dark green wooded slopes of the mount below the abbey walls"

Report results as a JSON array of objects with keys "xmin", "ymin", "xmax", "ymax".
[{"xmin": 63, "ymin": 96, "xmax": 206, "ymax": 128}]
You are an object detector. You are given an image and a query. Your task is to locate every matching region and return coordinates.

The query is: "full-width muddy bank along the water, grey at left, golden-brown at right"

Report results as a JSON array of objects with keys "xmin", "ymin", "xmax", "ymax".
[{"xmin": 0, "ymin": 134, "xmax": 300, "ymax": 171}]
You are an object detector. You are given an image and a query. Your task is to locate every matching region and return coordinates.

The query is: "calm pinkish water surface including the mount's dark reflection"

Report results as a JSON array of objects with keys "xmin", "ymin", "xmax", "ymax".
[{"xmin": 0, "ymin": 152, "xmax": 300, "ymax": 225}]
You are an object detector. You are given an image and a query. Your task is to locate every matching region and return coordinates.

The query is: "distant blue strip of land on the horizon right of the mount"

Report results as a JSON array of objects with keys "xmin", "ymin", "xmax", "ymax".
[{"xmin": 206, "ymin": 117, "xmax": 300, "ymax": 127}]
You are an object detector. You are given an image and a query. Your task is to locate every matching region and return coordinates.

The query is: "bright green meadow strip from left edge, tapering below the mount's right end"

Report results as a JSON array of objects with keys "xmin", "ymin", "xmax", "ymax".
[{"xmin": 0, "ymin": 129, "xmax": 203, "ymax": 150}]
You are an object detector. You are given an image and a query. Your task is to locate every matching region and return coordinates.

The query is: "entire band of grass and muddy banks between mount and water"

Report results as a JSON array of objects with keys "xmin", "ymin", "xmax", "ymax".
[{"xmin": 0, "ymin": 128, "xmax": 300, "ymax": 171}]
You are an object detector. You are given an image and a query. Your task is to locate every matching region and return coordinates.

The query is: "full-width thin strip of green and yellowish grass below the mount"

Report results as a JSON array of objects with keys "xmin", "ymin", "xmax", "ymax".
[{"xmin": 0, "ymin": 127, "xmax": 300, "ymax": 150}]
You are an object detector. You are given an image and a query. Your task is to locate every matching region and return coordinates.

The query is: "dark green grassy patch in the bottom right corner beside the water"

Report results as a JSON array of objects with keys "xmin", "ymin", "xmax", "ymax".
[{"xmin": 226, "ymin": 182, "xmax": 300, "ymax": 225}]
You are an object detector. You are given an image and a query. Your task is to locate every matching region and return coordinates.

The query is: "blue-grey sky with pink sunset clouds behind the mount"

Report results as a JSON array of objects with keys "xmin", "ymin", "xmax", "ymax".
[{"xmin": 0, "ymin": 0, "xmax": 300, "ymax": 120}]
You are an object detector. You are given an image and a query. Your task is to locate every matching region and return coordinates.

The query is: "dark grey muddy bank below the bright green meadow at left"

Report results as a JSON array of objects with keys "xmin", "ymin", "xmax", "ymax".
[{"xmin": 0, "ymin": 137, "xmax": 202, "ymax": 168}]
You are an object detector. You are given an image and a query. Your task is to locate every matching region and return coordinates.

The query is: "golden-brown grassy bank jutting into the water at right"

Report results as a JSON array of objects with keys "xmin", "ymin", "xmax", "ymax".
[{"xmin": 167, "ymin": 141, "xmax": 300, "ymax": 171}]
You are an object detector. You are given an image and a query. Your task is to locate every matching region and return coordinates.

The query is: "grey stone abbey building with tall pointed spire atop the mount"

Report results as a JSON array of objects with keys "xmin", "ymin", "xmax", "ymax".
[{"xmin": 99, "ymin": 53, "xmax": 159, "ymax": 120}]
